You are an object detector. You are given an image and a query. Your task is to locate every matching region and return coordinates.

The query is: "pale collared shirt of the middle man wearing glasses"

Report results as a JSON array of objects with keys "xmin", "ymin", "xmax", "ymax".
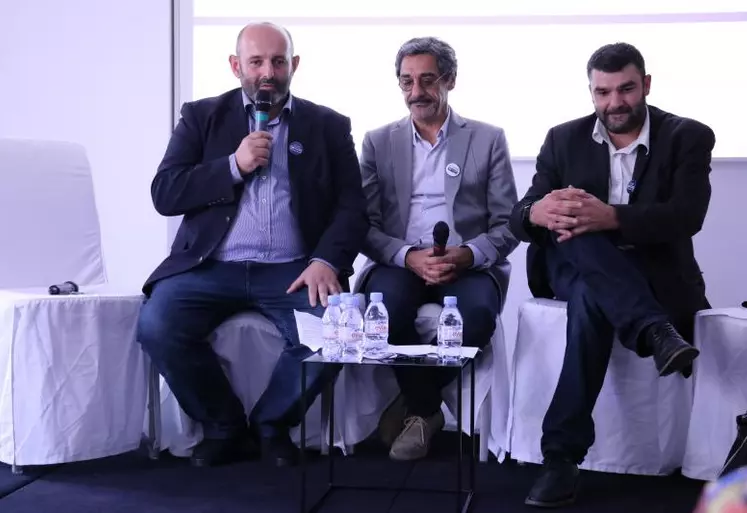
[{"xmin": 393, "ymin": 108, "xmax": 485, "ymax": 267}]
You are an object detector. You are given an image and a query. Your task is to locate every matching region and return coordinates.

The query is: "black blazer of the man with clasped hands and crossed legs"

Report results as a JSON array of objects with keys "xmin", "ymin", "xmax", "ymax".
[{"xmin": 511, "ymin": 106, "xmax": 715, "ymax": 337}]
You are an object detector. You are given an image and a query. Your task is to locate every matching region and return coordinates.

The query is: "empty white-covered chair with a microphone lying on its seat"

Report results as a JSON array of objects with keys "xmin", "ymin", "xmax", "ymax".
[{"xmin": 0, "ymin": 139, "xmax": 146, "ymax": 467}]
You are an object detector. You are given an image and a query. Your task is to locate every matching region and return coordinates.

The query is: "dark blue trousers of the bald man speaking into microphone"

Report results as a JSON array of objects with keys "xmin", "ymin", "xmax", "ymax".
[{"xmin": 138, "ymin": 261, "xmax": 332, "ymax": 438}]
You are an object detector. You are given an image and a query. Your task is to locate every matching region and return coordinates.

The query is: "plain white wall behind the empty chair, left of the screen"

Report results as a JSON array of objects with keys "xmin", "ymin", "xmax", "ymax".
[{"xmin": 0, "ymin": 0, "xmax": 171, "ymax": 288}]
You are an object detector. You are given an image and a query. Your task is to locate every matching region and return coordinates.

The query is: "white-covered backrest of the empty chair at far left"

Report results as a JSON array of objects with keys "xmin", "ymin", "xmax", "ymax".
[{"xmin": 0, "ymin": 139, "xmax": 106, "ymax": 289}]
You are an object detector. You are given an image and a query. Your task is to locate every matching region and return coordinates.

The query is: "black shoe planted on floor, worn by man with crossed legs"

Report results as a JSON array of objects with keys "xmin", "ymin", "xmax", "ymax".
[{"xmin": 524, "ymin": 460, "xmax": 578, "ymax": 508}]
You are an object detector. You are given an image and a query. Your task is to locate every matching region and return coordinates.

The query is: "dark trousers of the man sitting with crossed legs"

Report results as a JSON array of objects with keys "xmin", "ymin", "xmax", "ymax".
[{"xmin": 542, "ymin": 233, "xmax": 667, "ymax": 463}]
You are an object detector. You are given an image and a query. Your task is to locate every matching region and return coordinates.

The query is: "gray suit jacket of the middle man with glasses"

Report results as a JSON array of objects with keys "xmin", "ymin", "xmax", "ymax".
[{"xmin": 356, "ymin": 110, "xmax": 519, "ymax": 299}]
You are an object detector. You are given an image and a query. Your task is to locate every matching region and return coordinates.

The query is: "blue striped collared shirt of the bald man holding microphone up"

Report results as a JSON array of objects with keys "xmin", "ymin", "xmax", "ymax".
[{"xmin": 212, "ymin": 91, "xmax": 305, "ymax": 263}]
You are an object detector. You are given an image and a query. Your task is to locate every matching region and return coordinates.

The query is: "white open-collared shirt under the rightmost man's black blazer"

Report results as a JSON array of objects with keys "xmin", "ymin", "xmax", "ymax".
[{"xmin": 591, "ymin": 107, "xmax": 651, "ymax": 205}]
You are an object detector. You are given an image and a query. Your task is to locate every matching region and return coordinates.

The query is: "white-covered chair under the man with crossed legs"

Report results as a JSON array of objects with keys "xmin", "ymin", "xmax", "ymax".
[{"xmin": 509, "ymin": 299, "xmax": 692, "ymax": 475}]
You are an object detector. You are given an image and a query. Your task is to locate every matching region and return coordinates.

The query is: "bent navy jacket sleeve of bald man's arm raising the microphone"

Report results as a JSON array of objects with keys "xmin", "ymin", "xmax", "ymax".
[{"xmin": 151, "ymin": 103, "xmax": 237, "ymax": 216}]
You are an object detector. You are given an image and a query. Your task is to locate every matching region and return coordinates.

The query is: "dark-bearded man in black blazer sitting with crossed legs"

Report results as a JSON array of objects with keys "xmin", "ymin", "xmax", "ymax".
[{"xmin": 511, "ymin": 43, "xmax": 715, "ymax": 507}]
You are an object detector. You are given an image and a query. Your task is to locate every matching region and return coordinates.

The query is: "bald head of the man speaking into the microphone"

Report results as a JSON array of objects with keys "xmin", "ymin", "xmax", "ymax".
[{"xmin": 229, "ymin": 22, "xmax": 299, "ymax": 104}]
